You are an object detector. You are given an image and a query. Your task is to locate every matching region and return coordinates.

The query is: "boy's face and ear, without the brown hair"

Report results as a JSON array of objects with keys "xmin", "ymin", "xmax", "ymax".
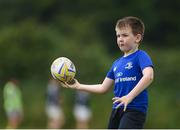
[{"xmin": 116, "ymin": 26, "xmax": 141, "ymax": 53}]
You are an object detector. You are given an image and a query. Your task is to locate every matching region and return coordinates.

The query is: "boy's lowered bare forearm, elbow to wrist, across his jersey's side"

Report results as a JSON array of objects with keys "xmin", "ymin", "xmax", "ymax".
[{"xmin": 127, "ymin": 76, "xmax": 153, "ymax": 100}]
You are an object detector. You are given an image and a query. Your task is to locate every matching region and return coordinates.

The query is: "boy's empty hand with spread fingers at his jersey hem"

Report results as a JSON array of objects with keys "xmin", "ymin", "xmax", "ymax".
[{"xmin": 112, "ymin": 95, "xmax": 132, "ymax": 111}]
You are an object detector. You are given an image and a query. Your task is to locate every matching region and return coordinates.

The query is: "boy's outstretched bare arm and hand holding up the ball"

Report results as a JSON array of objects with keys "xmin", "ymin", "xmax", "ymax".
[{"xmin": 62, "ymin": 77, "xmax": 114, "ymax": 93}]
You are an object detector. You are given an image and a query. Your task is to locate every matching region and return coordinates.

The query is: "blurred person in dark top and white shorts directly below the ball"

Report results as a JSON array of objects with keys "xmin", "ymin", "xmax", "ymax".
[{"xmin": 46, "ymin": 78, "xmax": 64, "ymax": 129}]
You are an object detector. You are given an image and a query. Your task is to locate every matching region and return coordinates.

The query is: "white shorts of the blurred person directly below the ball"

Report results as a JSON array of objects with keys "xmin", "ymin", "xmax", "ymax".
[{"xmin": 46, "ymin": 105, "xmax": 63, "ymax": 119}]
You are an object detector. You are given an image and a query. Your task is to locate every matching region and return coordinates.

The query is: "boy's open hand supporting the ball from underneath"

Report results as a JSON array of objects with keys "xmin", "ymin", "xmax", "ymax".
[{"xmin": 60, "ymin": 79, "xmax": 80, "ymax": 89}]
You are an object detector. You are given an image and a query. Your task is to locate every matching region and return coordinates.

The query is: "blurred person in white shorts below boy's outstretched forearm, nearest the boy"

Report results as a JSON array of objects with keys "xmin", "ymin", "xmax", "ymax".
[{"xmin": 74, "ymin": 91, "xmax": 92, "ymax": 129}]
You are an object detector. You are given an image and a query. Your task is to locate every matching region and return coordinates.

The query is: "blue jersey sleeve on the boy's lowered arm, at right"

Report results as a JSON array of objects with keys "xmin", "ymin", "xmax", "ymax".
[{"xmin": 138, "ymin": 51, "xmax": 153, "ymax": 71}]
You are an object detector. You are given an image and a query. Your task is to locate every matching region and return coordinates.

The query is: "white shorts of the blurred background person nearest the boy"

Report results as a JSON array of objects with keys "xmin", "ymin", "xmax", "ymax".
[{"xmin": 74, "ymin": 105, "xmax": 92, "ymax": 121}]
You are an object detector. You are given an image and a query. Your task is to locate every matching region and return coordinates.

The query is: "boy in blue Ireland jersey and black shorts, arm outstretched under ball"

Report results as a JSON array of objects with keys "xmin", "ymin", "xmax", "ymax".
[{"xmin": 61, "ymin": 17, "xmax": 154, "ymax": 129}]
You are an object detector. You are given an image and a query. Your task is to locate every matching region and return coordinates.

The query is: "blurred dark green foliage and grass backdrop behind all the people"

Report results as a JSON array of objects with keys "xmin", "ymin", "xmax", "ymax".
[{"xmin": 0, "ymin": 0, "xmax": 180, "ymax": 128}]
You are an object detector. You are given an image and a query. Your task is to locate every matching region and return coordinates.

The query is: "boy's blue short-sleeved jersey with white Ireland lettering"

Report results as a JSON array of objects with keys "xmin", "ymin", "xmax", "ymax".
[{"xmin": 107, "ymin": 50, "xmax": 153, "ymax": 113}]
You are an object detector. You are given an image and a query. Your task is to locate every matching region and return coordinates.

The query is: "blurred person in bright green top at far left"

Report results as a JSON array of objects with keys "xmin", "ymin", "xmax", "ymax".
[{"xmin": 3, "ymin": 78, "xmax": 23, "ymax": 129}]
